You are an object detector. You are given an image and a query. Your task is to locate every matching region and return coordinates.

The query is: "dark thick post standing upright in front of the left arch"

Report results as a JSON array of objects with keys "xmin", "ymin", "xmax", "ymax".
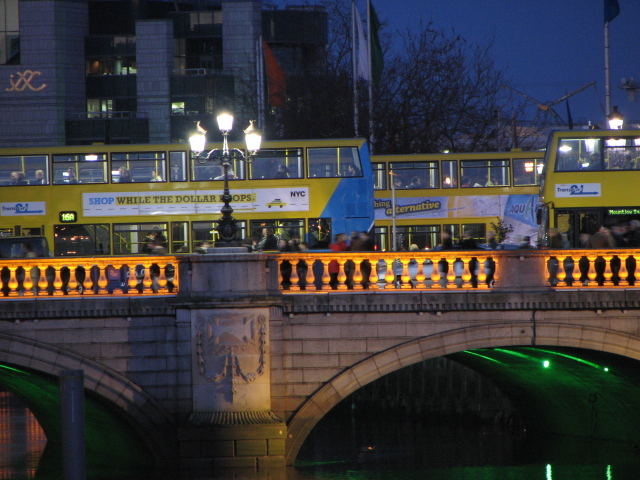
[{"xmin": 60, "ymin": 370, "xmax": 86, "ymax": 480}]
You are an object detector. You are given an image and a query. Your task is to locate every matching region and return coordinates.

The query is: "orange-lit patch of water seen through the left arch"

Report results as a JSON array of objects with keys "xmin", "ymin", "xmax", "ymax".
[{"xmin": 0, "ymin": 391, "xmax": 47, "ymax": 480}]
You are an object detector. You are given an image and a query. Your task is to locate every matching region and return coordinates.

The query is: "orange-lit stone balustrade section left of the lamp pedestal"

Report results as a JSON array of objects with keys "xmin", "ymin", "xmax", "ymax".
[{"xmin": 0, "ymin": 256, "xmax": 179, "ymax": 298}]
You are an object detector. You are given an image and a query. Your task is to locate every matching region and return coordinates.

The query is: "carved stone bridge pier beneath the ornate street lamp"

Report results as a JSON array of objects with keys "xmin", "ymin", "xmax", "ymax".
[{"xmin": 177, "ymin": 253, "xmax": 287, "ymax": 473}]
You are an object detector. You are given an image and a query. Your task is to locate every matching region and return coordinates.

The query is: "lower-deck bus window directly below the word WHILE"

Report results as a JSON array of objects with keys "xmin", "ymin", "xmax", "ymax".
[{"xmin": 113, "ymin": 223, "xmax": 167, "ymax": 255}]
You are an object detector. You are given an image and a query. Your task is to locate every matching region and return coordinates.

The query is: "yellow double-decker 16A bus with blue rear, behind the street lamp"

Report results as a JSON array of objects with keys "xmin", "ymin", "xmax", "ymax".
[{"xmin": 0, "ymin": 139, "xmax": 373, "ymax": 256}]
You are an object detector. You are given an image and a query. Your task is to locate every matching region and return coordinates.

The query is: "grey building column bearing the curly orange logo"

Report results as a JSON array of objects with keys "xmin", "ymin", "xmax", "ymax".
[{"xmin": 0, "ymin": 0, "xmax": 89, "ymax": 146}]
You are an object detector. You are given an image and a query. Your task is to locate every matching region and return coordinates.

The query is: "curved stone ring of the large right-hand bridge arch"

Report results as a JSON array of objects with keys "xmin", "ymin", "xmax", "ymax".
[{"xmin": 286, "ymin": 318, "xmax": 640, "ymax": 464}]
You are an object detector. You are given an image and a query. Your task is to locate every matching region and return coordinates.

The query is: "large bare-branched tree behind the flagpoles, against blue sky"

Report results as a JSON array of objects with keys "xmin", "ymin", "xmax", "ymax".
[{"xmin": 269, "ymin": 0, "xmax": 529, "ymax": 153}]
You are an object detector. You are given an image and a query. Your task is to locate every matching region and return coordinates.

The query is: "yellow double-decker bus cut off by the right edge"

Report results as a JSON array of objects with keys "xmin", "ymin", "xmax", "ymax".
[{"xmin": 542, "ymin": 130, "xmax": 640, "ymax": 247}]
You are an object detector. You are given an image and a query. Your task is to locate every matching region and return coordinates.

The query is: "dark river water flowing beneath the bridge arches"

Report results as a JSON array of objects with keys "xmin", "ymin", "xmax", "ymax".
[{"xmin": 0, "ymin": 394, "xmax": 640, "ymax": 480}]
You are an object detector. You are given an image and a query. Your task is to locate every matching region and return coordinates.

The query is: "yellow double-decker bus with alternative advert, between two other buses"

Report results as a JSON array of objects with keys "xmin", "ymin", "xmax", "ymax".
[{"xmin": 372, "ymin": 150, "xmax": 544, "ymax": 250}]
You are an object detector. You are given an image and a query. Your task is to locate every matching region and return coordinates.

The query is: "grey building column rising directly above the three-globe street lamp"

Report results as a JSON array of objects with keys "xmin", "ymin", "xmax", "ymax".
[{"xmin": 222, "ymin": 0, "xmax": 262, "ymax": 120}]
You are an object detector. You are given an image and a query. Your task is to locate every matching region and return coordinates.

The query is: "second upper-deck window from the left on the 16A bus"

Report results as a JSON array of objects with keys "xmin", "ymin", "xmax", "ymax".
[{"xmin": 53, "ymin": 153, "xmax": 107, "ymax": 185}]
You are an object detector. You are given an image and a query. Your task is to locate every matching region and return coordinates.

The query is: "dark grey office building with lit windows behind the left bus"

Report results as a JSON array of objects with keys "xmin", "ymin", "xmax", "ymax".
[{"xmin": 0, "ymin": 0, "xmax": 327, "ymax": 146}]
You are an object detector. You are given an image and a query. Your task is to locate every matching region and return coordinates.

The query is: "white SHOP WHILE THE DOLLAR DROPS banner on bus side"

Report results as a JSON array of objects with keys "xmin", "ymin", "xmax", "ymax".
[{"xmin": 82, "ymin": 187, "xmax": 309, "ymax": 217}]
